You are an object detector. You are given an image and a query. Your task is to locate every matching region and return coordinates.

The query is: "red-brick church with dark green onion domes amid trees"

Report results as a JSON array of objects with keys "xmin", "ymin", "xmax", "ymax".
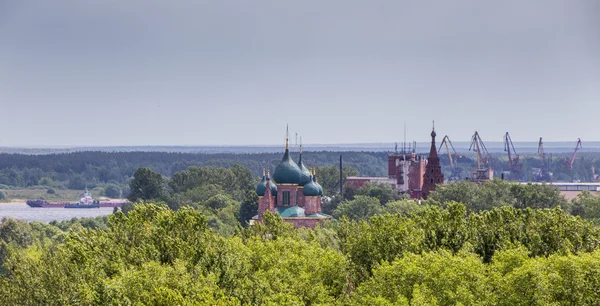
[{"xmin": 252, "ymin": 133, "xmax": 331, "ymax": 228}]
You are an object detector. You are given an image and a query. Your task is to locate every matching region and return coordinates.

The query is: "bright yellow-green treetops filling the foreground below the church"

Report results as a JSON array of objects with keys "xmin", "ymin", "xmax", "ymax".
[{"xmin": 0, "ymin": 200, "xmax": 600, "ymax": 305}]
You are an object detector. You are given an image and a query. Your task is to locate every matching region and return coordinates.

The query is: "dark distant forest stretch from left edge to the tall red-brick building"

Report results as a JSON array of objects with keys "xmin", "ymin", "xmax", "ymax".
[{"xmin": 0, "ymin": 152, "xmax": 387, "ymax": 190}]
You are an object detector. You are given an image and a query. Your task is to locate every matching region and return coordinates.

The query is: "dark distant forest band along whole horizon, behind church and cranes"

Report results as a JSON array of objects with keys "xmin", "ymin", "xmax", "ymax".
[{"xmin": 0, "ymin": 151, "xmax": 600, "ymax": 194}]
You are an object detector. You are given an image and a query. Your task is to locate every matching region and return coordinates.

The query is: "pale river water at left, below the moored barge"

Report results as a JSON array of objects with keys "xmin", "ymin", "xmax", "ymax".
[{"xmin": 0, "ymin": 203, "xmax": 114, "ymax": 222}]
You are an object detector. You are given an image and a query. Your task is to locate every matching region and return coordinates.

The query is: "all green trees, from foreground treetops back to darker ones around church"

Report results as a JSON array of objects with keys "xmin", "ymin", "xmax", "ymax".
[{"xmin": 0, "ymin": 158, "xmax": 600, "ymax": 305}]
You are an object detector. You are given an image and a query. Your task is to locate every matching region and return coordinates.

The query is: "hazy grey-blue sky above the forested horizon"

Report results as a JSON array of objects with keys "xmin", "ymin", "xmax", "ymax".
[{"xmin": 0, "ymin": 0, "xmax": 600, "ymax": 146}]
